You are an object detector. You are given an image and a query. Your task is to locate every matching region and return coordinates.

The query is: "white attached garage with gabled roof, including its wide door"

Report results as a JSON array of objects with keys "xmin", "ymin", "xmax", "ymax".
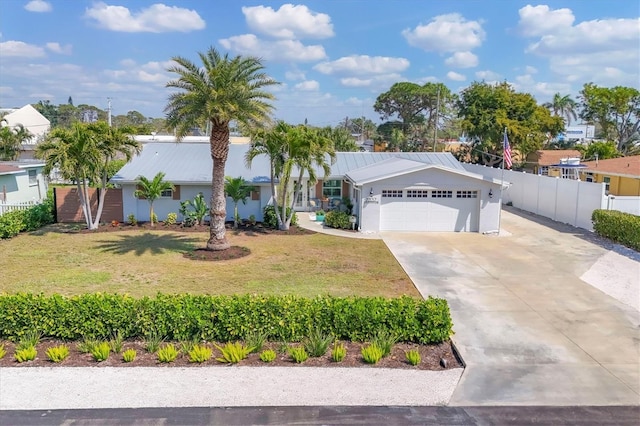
[{"xmin": 346, "ymin": 158, "xmax": 502, "ymax": 233}]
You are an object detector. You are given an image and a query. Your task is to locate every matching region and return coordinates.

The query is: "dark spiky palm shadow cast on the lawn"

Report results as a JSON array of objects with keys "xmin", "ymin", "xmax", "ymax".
[{"xmin": 97, "ymin": 232, "xmax": 200, "ymax": 256}]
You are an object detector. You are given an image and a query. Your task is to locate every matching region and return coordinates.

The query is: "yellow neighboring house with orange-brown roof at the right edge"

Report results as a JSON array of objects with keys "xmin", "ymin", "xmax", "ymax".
[{"xmin": 580, "ymin": 155, "xmax": 640, "ymax": 197}]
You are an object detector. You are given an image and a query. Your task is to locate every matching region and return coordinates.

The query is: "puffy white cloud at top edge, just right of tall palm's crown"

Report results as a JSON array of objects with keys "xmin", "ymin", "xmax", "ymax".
[{"xmin": 242, "ymin": 4, "xmax": 334, "ymax": 39}]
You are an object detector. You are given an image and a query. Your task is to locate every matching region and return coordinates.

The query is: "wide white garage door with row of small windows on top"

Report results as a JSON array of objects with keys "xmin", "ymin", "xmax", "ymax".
[{"xmin": 380, "ymin": 189, "xmax": 480, "ymax": 232}]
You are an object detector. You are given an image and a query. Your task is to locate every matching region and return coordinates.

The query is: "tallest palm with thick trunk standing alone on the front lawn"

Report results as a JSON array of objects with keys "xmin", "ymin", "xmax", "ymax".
[{"xmin": 165, "ymin": 47, "xmax": 278, "ymax": 250}]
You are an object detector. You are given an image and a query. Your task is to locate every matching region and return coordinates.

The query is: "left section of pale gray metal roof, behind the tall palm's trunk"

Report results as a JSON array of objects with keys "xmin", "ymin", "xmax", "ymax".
[{"xmin": 111, "ymin": 142, "xmax": 270, "ymax": 184}]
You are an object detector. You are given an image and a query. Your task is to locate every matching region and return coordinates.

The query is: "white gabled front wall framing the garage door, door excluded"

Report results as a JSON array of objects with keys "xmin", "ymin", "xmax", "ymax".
[{"xmin": 354, "ymin": 170, "xmax": 500, "ymax": 232}]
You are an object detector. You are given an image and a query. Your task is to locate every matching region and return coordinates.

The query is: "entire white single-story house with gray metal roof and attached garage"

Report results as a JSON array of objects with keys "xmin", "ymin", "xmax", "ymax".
[{"xmin": 111, "ymin": 142, "xmax": 502, "ymax": 232}]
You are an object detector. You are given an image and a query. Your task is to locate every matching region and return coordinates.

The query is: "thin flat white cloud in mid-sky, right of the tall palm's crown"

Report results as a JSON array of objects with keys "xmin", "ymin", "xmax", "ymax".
[{"xmin": 313, "ymin": 55, "xmax": 409, "ymax": 75}]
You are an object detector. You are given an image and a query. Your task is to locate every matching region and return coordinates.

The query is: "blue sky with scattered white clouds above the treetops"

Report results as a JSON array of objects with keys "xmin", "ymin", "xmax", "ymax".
[{"xmin": 0, "ymin": 0, "xmax": 640, "ymax": 126}]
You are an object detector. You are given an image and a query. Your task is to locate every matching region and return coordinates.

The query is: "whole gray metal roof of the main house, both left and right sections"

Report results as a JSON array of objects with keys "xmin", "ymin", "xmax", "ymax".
[{"xmin": 111, "ymin": 142, "xmax": 468, "ymax": 184}]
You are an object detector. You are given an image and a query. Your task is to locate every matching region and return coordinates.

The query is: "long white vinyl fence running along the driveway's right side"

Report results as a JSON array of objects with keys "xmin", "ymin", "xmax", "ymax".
[{"xmin": 463, "ymin": 164, "xmax": 608, "ymax": 230}]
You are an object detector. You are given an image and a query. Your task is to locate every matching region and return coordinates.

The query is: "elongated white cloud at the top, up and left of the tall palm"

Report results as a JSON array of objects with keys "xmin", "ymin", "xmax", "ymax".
[{"xmin": 85, "ymin": 2, "xmax": 205, "ymax": 33}]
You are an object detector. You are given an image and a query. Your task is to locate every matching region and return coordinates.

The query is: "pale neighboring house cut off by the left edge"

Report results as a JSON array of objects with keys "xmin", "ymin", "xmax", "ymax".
[{"xmin": 0, "ymin": 161, "xmax": 47, "ymax": 214}]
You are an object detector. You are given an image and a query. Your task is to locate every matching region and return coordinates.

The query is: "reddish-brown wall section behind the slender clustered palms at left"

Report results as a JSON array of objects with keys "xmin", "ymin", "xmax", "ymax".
[{"xmin": 53, "ymin": 187, "xmax": 124, "ymax": 223}]
